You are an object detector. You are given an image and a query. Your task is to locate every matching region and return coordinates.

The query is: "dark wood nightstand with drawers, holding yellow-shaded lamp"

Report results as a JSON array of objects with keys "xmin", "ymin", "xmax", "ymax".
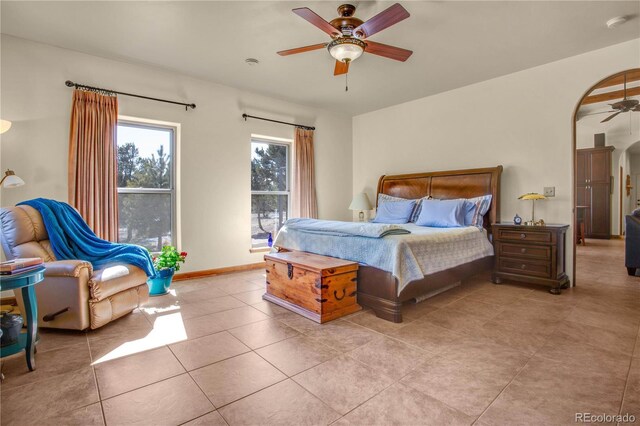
[{"xmin": 492, "ymin": 223, "xmax": 569, "ymax": 294}]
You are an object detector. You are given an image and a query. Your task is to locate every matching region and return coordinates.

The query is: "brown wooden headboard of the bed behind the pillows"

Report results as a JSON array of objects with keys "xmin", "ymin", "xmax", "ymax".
[{"xmin": 376, "ymin": 166, "xmax": 502, "ymax": 232}]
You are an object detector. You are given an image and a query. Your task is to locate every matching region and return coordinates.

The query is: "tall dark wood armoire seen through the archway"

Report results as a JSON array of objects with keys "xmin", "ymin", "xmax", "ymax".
[{"xmin": 576, "ymin": 146, "xmax": 614, "ymax": 238}]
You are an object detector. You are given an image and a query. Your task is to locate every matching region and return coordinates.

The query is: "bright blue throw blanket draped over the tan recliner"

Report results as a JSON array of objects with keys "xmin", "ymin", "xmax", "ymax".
[{"xmin": 18, "ymin": 198, "xmax": 155, "ymax": 277}]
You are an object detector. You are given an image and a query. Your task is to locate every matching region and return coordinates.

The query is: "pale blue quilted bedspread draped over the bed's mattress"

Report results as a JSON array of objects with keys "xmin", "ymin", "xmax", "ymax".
[{"xmin": 274, "ymin": 223, "xmax": 493, "ymax": 295}]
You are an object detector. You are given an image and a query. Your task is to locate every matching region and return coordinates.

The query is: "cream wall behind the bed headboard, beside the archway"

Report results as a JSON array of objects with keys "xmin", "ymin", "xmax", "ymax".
[{"xmin": 353, "ymin": 40, "xmax": 640, "ymax": 282}]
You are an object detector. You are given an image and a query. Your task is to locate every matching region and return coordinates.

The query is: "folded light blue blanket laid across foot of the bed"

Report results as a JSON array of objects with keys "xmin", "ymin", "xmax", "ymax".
[{"xmin": 285, "ymin": 219, "xmax": 411, "ymax": 238}]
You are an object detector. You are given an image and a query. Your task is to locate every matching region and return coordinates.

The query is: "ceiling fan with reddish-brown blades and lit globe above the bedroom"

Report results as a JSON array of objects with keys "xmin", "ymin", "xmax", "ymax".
[{"xmin": 278, "ymin": 3, "xmax": 413, "ymax": 75}]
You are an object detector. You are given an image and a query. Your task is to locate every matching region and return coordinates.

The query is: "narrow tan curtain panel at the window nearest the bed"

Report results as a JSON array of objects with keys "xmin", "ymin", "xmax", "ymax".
[{"xmin": 293, "ymin": 127, "xmax": 318, "ymax": 218}]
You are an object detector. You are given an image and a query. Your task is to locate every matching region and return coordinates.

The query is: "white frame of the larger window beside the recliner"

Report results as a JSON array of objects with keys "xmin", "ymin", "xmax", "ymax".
[{"xmin": 116, "ymin": 116, "xmax": 181, "ymax": 253}]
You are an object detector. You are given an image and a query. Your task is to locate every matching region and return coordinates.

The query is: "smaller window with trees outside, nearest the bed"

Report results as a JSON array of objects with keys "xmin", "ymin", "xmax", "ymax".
[{"xmin": 251, "ymin": 137, "xmax": 291, "ymax": 248}]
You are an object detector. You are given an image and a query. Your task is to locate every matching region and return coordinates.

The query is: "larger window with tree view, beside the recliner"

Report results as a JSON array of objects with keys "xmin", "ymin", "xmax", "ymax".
[{"xmin": 118, "ymin": 120, "xmax": 177, "ymax": 251}]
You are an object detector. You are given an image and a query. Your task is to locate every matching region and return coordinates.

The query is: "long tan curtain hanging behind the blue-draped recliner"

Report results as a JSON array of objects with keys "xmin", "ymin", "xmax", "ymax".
[{"xmin": 69, "ymin": 90, "xmax": 118, "ymax": 241}]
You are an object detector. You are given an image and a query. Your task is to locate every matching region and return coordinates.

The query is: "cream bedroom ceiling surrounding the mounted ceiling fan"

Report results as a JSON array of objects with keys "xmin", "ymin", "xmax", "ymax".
[{"xmin": 0, "ymin": 0, "xmax": 640, "ymax": 115}]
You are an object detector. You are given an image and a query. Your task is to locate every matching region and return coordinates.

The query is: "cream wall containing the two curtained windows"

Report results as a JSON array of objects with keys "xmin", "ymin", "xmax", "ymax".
[{"xmin": 0, "ymin": 35, "xmax": 352, "ymax": 271}]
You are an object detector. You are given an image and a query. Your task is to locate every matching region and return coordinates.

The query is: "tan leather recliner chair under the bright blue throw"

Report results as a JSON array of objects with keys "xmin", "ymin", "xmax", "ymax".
[{"xmin": 0, "ymin": 205, "xmax": 149, "ymax": 330}]
